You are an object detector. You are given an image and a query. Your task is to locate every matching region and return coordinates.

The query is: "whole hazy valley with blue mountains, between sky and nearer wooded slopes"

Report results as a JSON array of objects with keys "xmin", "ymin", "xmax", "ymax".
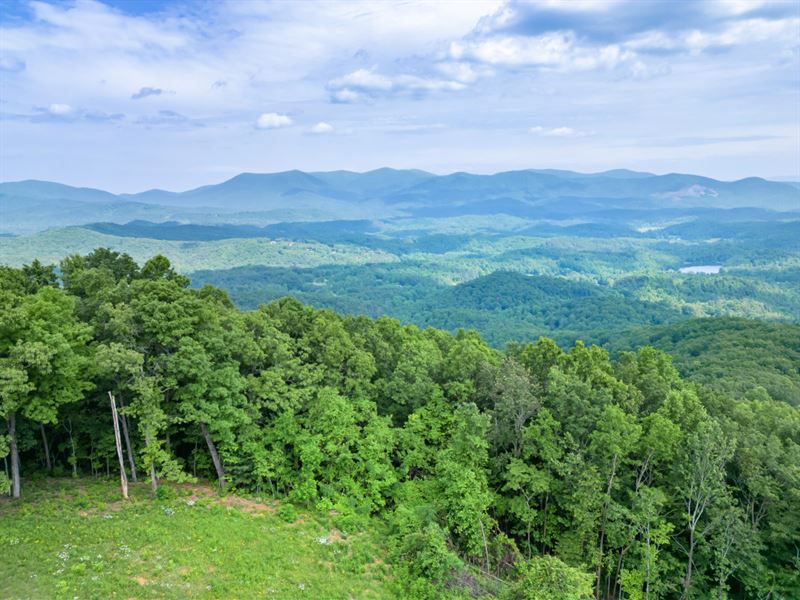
[{"xmin": 0, "ymin": 169, "xmax": 800, "ymax": 347}]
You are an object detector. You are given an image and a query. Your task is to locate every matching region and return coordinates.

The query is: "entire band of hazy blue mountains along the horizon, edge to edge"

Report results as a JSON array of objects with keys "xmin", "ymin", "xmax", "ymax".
[{"xmin": 0, "ymin": 168, "xmax": 800, "ymax": 234}]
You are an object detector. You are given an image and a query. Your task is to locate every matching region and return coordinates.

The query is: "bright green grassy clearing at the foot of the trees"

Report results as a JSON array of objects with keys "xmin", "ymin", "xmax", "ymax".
[{"xmin": 0, "ymin": 479, "xmax": 395, "ymax": 599}]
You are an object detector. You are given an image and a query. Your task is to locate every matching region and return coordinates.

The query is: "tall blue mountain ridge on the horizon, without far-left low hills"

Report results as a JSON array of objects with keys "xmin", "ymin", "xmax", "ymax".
[{"xmin": 123, "ymin": 169, "xmax": 800, "ymax": 214}]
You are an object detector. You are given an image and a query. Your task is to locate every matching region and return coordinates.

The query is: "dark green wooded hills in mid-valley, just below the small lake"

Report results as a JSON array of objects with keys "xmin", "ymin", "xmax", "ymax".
[{"xmin": 192, "ymin": 261, "xmax": 800, "ymax": 348}]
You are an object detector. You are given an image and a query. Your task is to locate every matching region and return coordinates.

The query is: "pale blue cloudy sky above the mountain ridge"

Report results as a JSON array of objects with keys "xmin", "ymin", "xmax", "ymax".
[{"xmin": 0, "ymin": 0, "xmax": 800, "ymax": 192}]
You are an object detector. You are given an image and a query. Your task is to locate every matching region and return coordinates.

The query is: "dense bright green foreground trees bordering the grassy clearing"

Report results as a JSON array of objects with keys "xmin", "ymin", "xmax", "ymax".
[{"xmin": 0, "ymin": 249, "xmax": 800, "ymax": 599}]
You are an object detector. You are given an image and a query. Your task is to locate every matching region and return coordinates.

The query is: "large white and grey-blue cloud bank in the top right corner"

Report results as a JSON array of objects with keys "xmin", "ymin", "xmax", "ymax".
[{"xmin": 448, "ymin": 0, "xmax": 800, "ymax": 79}]
